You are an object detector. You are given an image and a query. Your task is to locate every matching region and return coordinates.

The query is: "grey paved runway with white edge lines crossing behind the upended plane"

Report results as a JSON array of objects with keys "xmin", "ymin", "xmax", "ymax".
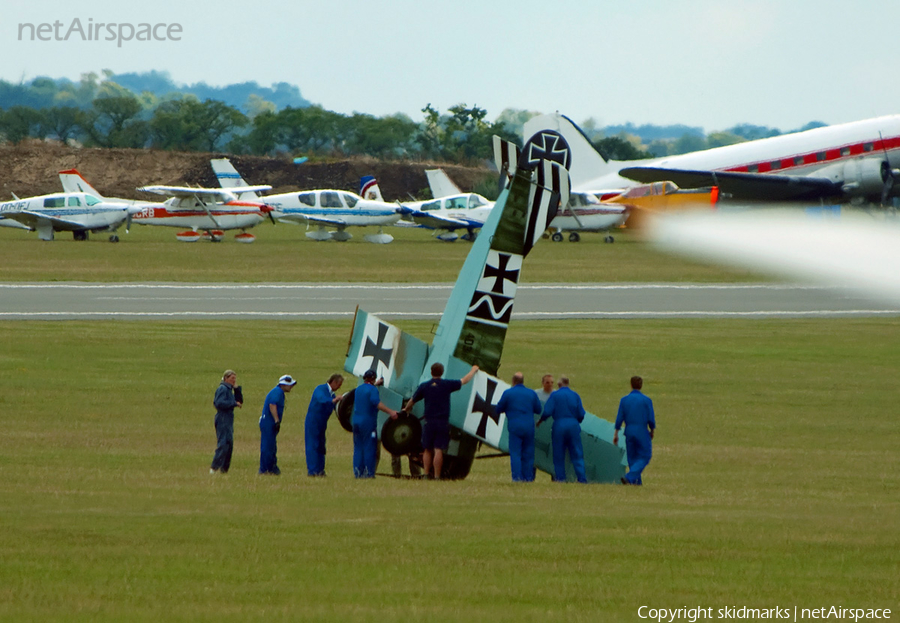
[{"xmin": 0, "ymin": 283, "xmax": 900, "ymax": 320}]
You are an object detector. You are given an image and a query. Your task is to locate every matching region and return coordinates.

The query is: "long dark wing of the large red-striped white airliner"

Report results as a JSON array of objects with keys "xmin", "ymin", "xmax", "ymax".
[{"xmin": 619, "ymin": 167, "xmax": 841, "ymax": 201}]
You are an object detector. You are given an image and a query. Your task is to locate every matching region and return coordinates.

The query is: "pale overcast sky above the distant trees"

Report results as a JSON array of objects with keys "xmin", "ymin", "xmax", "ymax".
[{"xmin": 0, "ymin": 0, "xmax": 900, "ymax": 131}]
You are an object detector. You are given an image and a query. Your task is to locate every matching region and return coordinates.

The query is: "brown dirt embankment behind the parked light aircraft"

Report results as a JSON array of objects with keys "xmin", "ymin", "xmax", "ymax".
[{"xmin": 0, "ymin": 141, "xmax": 491, "ymax": 201}]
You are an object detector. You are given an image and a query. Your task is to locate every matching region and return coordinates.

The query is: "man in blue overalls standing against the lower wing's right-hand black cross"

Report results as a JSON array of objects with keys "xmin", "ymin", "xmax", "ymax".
[{"xmin": 497, "ymin": 372, "xmax": 542, "ymax": 482}]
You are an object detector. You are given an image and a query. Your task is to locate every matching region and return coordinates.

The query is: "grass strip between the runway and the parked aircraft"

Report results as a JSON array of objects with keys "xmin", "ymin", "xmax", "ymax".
[{"xmin": 0, "ymin": 223, "xmax": 766, "ymax": 283}]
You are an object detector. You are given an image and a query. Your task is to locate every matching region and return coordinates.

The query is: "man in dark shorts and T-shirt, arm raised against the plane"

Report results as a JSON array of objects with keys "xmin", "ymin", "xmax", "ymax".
[{"xmin": 406, "ymin": 363, "xmax": 478, "ymax": 480}]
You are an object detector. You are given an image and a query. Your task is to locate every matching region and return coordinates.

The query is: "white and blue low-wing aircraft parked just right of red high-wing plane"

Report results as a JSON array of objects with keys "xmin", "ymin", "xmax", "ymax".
[{"xmin": 210, "ymin": 158, "xmax": 404, "ymax": 244}]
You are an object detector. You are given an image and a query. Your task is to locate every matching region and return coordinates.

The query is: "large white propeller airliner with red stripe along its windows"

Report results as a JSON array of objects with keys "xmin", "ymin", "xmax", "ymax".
[{"xmin": 525, "ymin": 113, "xmax": 900, "ymax": 204}]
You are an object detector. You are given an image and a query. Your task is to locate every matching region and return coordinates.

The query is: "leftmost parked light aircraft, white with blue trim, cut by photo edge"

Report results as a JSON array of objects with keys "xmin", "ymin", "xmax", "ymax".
[{"xmin": 0, "ymin": 182, "xmax": 140, "ymax": 242}]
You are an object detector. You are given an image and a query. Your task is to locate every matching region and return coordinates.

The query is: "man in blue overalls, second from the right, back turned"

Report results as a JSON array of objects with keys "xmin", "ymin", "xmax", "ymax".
[{"xmin": 538, "ymin": 376, "xmax": 587, "ymax": 483}]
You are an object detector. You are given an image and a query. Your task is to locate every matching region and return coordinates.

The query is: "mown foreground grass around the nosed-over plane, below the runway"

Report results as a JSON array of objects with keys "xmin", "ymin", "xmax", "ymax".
[{"xmin": 0, "ymin": 320, "xmax": 900, "ymax": 622}]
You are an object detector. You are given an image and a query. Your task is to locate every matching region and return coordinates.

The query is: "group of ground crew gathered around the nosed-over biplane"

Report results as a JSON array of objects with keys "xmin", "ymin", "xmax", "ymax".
[{"xmin": 210, "ymin": 363, "xmax": 656, "ymax": 485}]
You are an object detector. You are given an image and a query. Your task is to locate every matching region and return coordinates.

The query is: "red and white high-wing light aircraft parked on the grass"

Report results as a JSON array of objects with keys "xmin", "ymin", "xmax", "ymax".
[{"xmin": 134, "ymin": 178, "xmax": 274, "ymax": 242}]
